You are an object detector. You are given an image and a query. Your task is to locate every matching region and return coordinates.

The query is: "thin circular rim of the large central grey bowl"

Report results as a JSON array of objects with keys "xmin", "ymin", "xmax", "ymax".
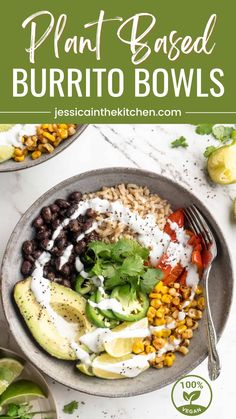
[{"xmin": 0, "ymin": 166, "xmax": 234, "ymax": 398}]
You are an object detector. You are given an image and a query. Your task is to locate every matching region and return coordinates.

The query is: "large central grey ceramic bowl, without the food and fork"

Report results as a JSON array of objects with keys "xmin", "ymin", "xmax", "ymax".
[{"xmin": 2, "ymin": 168, "xmax": 233, "ymax": 397}]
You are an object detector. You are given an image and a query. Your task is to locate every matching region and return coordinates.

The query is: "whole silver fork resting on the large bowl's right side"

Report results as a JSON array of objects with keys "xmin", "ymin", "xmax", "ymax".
[{"xmin": 184, "ymin": 205, "xmax": 221, "ymax": 381}]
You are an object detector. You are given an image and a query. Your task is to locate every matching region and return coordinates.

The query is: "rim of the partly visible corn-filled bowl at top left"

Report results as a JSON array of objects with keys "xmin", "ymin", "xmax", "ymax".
[{"xmin": 0, "ymin": 124, "xmax": 89, "ymax": 176}]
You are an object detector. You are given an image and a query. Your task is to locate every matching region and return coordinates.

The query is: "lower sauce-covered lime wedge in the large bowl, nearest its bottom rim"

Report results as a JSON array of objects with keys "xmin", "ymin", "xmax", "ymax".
[{"xmin": 93, "ymin": 354, "xmax": 149, "ymax": 380}]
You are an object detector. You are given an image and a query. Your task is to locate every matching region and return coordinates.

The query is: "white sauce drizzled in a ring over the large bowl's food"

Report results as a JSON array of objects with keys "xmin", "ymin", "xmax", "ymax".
[{"xmin": 28, "ymin": 198, "xmax": 199, "ymax": 370}]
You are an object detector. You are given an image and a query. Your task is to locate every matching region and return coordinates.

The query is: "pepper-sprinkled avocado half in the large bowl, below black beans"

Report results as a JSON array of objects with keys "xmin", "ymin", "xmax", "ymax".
[{"xmin": 14, "ymin": 278, "xmax": 93, "ymax": 361}]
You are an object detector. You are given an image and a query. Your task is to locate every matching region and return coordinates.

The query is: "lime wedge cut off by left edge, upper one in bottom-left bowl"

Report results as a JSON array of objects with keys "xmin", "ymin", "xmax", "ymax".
[{"xmin": 0, "ymin": 358, "xmax": 24, "ymax": 395}]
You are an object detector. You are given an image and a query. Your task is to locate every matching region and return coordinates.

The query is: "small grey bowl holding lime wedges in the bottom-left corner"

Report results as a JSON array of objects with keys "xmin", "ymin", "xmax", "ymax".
[{"xmin": 0, "ymin": 347, "xmax": 58, "ymax": 419}]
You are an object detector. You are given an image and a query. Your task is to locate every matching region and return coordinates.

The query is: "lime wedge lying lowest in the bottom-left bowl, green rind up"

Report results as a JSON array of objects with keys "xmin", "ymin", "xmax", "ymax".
[{"xmin": 0, "ymin": 380, "xmax": 46, "ymax": 406}]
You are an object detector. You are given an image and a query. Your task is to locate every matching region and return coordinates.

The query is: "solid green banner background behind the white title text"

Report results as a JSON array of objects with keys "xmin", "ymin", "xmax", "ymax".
[{"xmin": 0, "ymin": 0, "xmax": 236, "ymax": 123}]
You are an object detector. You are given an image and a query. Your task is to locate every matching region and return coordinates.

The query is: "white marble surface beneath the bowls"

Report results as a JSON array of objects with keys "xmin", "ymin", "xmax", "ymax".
[{"xmin": 0, "ymin": 125, "xmax": 236, "ymax": 419}]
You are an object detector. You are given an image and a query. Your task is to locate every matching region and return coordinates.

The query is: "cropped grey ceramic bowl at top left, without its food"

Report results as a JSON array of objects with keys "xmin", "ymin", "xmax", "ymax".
[{"xmin": 0, "ymin": 124, "xmax": 88, "ymax": 172}]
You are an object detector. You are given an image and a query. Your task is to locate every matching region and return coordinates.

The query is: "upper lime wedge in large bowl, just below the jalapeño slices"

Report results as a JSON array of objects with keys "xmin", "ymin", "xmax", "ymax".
[{"xmin": 104, "ymin": 317, "xmax": 148, "ymax": 358}]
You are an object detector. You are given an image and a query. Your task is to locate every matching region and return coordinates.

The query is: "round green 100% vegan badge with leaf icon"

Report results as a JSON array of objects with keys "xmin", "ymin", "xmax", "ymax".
[{"xmin": 171, "ymin": 375, "xmax": 213, "ymax": 416}]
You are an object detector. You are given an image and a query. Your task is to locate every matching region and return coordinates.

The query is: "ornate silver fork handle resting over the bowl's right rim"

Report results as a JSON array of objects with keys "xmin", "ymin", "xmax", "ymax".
[{"xmin": 204, "ymin": 269, "xmax": 221, "ymax": 381}]
